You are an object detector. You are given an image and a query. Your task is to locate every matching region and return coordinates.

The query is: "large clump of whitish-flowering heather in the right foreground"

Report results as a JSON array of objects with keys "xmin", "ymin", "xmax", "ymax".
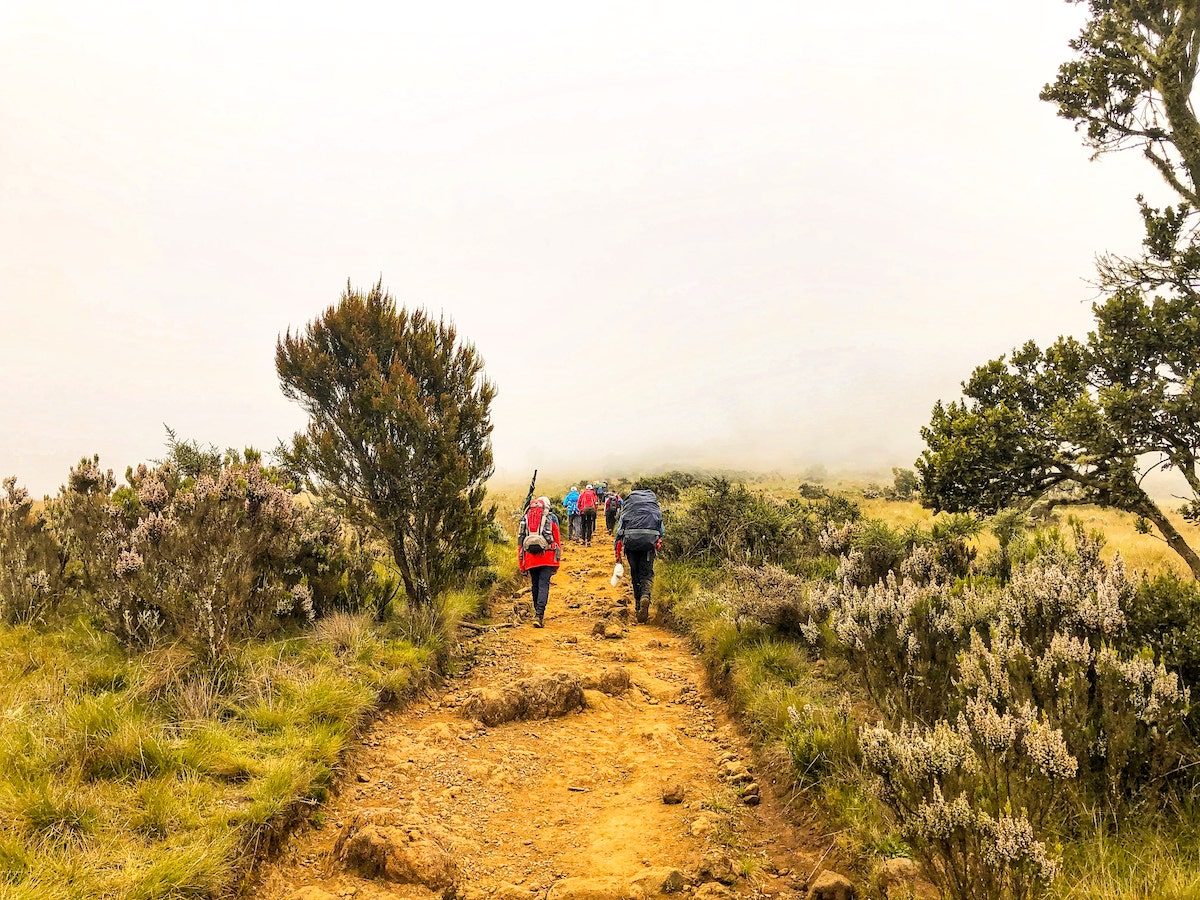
[{"xmin": 823, "ymin": 534, "xmax": 1188, "ymax": 900}]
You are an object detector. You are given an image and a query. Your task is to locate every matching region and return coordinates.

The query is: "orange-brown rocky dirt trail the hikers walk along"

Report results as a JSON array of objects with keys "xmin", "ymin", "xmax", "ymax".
[{"xmin": 253, "ymin": 528, "xmax": 829, "ymax": 900}]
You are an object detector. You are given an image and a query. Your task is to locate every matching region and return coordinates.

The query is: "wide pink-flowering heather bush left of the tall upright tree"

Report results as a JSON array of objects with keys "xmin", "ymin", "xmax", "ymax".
[{"xmin": 35, "ymin": 455, "xmax": 380, "ymax": 659}]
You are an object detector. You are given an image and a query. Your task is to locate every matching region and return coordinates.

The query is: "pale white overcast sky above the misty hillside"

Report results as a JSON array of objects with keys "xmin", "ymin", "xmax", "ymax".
[{"xmin": 0, "ymin": 0, "xmax": 1159, "ymax": 494}]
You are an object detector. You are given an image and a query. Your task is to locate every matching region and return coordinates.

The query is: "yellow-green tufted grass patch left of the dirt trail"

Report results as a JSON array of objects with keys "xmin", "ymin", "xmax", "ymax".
[{"xmin": 0, "ymin": 614, "xmax": 437, "ymax": 900}]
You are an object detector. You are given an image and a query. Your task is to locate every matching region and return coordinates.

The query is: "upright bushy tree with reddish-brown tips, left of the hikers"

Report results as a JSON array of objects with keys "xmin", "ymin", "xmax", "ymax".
[{"xmin": 275, "ymin": 282, "xmax": 496, "ymax": 606}]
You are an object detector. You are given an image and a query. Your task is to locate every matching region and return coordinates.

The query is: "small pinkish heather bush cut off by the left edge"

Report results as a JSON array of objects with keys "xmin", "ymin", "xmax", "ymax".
[{"xmin": 0, "ymin": 478, "xmax": 60, "ymax": 624}]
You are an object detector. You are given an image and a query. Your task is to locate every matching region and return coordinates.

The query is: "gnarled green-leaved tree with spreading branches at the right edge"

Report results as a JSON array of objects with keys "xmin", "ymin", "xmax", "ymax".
[{"xmin": 917, "ymin": 0, "xmax": 1200, "ymax": 578}]
